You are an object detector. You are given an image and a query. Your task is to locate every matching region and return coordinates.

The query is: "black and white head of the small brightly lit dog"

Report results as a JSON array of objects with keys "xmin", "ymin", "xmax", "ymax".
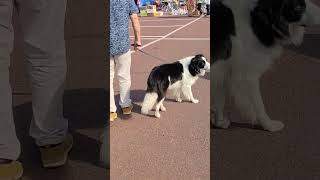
[{"xmin": 189, "ymin": 54, "xmax": 210, "ymax": 76}]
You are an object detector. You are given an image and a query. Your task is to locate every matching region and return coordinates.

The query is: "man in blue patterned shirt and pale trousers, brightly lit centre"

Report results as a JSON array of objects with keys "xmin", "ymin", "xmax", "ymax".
[{"xmin": 110, "ymin": 0, "xmax": 141, "ymax": 121}]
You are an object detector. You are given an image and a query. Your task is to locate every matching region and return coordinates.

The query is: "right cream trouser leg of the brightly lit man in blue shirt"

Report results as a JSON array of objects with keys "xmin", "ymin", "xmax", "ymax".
[{"xmin": 115, "ymin": 51, "xmax": 132, "ymax": 111}]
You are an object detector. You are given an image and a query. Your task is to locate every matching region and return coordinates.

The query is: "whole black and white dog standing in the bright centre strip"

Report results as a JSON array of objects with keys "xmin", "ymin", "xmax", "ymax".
[{"xmin": 141, "ymin": 54, "xmax": 210, "ymax": 118}]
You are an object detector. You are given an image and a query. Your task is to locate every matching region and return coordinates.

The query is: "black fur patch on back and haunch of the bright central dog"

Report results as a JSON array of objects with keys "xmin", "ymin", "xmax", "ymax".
[{"xmin": 147, "ymin": 62, "xmax": 183, "ymax": 102}]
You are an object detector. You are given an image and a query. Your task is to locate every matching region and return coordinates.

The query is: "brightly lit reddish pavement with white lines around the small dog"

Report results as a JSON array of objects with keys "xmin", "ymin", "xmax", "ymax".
[{"xmin": 110, "ymin": 17, "xmax": 210, "ymax": 180}]
